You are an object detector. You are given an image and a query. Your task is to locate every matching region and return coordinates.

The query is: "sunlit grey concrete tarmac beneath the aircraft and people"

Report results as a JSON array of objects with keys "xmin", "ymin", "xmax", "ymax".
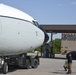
[{"xmin": 0, "ymin": 55, "xmax": 76, "ymax": 75}]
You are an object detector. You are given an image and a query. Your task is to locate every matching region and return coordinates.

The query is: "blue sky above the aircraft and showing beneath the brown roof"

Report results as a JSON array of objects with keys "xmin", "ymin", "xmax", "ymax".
[{"xmin": 0, "ymin": 0, "xmax": 76, "ymax": 38}]
